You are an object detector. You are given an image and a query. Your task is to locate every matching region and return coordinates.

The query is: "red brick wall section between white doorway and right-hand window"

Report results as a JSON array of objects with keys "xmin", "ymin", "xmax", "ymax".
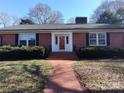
[{"xmin": 73, "ymin": 33, "xmax": 86, "ymax": 48}]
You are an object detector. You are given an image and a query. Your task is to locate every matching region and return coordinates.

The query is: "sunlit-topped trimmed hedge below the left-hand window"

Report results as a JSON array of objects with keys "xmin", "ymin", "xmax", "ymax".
[{"xmin": 0, "ymin": 46, "xmax": 49, "ymax": 60}]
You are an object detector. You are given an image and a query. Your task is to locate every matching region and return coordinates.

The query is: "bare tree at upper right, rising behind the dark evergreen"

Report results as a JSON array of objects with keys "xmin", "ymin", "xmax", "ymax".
[{"xmin": 90, "ymin": 0, "xmax": 124, "ymax": 23}]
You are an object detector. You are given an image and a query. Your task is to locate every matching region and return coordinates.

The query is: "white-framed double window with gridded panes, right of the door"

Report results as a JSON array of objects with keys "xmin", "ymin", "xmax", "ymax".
[{"xmin": 89, "ymin": 33, "xmax": 106, "ymax": 46}]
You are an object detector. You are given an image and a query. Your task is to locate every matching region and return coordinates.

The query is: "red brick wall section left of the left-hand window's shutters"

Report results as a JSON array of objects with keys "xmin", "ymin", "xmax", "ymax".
[{"xmin": 0, "ymin": 34, "xmax": 15, "ymax": 45}]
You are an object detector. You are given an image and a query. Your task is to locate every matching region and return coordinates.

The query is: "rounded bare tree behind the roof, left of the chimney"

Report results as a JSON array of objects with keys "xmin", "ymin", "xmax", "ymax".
[{"xmin": 28, "ymin": 3, "xmax": 63, "ymax": 24}]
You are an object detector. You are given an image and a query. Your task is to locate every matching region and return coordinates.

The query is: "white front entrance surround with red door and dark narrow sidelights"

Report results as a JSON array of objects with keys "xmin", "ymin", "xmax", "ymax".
[{"xmin": 51, "ymin": 32, "xmax": 73, "ymax": 52}]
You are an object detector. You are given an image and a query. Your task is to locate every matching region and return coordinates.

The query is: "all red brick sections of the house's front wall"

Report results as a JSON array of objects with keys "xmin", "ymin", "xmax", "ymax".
[{"xmin": 0, "ymin": 32, "xmax": 124, "ymax": 48}]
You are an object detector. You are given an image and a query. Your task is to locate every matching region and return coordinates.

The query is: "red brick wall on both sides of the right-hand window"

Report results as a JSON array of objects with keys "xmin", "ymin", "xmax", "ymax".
[{"xmin": 73, "ymin": 32, "xmax": 124, "ymax": 48}]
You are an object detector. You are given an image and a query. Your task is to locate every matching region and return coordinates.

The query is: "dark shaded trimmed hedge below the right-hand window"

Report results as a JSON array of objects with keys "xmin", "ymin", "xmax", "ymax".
[{"xmin": 77, "ymin": 47, "xmax": 124, "ymax": 58}]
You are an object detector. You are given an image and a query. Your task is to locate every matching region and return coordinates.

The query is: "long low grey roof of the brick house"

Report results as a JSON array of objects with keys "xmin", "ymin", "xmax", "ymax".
[{"xmin": 0, "ymin": 24, "xmax": 124, "ymax": 30}]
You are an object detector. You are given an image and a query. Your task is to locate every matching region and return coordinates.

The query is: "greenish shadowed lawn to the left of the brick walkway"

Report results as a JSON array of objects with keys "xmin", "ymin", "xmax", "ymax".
[{"xmin": 0, "ymin": 60, "xmax": 51, "ymax": 93}]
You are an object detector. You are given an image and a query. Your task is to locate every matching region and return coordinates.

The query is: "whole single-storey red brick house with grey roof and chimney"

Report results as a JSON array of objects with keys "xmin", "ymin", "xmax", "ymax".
[{"xmin": 0, "ymin": 18, "xmax": 124, "ymax": 52}]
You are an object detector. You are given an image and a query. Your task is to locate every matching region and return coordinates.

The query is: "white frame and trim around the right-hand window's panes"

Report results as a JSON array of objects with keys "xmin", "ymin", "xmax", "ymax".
[{"xmin": 88, "ymin": 32, "xmax": 107, "ymax": 46}]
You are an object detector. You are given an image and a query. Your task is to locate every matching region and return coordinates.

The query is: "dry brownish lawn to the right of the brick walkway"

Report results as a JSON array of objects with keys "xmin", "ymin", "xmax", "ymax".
[{"xmin": 74, "ymin": 59, "xmax": 124, "ymax": 93}]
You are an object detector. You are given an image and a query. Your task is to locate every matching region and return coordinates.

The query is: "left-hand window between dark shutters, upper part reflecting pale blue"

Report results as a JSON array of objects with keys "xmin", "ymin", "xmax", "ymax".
[{"xmin": 19, "ymin": 33, "xmax": 36, "ymax": 46}]
